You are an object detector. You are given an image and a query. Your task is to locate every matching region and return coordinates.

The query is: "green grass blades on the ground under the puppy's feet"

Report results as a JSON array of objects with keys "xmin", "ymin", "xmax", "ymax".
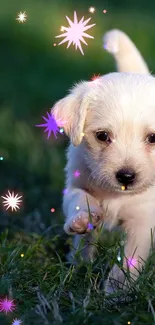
[{"xmin": 0, "ymin": 226, "xmax": 155, "ymax": 325}]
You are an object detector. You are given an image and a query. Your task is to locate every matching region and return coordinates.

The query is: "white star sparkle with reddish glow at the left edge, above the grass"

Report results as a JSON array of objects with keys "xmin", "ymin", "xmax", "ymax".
[{"xmin": 2, "ymin": 191, "xmax": 22, "ymax": 211}]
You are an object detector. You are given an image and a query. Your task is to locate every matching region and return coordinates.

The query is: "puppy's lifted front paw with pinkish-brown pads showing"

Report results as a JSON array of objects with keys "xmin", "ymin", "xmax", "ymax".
[{"xmin": 64, "ymin": 211, "xmax": 102, "ymax": 235}]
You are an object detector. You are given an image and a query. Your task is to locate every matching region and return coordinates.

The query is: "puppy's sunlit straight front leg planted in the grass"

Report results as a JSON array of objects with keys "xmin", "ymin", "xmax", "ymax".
[{"xmin": 105, "ymin": 207, "xmax": 155, "ymax": 294}]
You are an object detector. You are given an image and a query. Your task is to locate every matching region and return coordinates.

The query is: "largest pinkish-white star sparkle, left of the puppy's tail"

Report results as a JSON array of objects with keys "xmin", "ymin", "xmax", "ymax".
[{"xmin": 56, "ymin": 11, "xmax": 96, "ymax": 55}]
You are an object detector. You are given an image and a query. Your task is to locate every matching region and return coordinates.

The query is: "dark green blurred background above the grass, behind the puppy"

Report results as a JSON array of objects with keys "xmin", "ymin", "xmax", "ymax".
[{"xmin": 0, "ymin": 0, "xmax": 155, "ymax": 233}]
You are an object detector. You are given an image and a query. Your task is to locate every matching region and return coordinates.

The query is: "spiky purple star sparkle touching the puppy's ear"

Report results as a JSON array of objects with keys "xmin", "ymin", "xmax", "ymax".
[{"xmin": 35, "ymin": 112, "xmax": 60, "ymax": 139}]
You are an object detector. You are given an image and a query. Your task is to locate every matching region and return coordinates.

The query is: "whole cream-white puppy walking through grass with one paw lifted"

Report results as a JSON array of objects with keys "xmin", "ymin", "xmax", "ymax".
[{"xmin": 52, "ymin": 30, "xmax": 155, "ymax": 293}]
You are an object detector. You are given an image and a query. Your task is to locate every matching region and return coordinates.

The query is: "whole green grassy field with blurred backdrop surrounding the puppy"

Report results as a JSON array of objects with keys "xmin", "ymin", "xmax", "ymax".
[{"xmin": 0, "ymin": 0, "xmax": 155, "ymax": 325}]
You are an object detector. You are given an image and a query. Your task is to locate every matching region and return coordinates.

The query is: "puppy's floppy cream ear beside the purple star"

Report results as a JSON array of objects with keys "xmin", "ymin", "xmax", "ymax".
[{"xmin": 51, "ymin": 82, "xmax": 90, "ymax": 146}]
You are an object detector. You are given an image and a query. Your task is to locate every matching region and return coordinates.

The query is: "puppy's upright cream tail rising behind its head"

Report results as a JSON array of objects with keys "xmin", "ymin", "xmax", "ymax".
[{"xmin": 103, "ymin": 29, "xmax": 150, "ymax": 74}]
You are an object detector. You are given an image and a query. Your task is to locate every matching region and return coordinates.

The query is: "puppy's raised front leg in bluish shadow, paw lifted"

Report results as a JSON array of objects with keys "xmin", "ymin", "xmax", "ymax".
[{"xmin": 63, "ymin": 145, "xmax": 103, "ymax": 260}]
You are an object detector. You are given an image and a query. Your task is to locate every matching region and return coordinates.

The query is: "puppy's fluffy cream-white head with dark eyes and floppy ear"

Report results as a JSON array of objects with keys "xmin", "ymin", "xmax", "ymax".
[{"xmin": 52, "ymin": 73, "xmax": 155, "ymax": 193}]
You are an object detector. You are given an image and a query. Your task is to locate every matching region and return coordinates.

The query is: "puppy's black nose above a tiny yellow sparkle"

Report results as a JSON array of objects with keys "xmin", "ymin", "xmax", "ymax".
[{"xmin": 116, "ymin": 169, "xmax": 136, "ymax": 185}]
